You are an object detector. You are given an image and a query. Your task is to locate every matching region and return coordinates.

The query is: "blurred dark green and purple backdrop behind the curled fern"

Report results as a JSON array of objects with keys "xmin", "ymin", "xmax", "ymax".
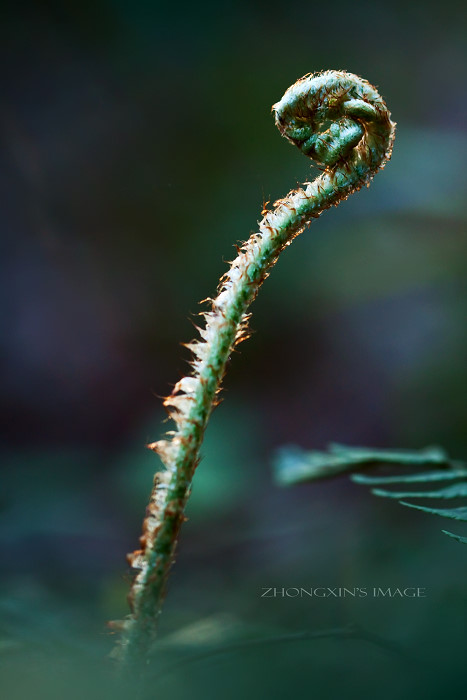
[{"xmin": 0, "ymin": 0, "xmax": 467, "ymax": 700}]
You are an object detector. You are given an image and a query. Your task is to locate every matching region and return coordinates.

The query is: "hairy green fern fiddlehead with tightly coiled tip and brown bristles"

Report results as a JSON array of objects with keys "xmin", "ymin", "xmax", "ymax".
[{"xmin": 115, "ymin": 71, "xmax": 395, "ymax": 662}]
